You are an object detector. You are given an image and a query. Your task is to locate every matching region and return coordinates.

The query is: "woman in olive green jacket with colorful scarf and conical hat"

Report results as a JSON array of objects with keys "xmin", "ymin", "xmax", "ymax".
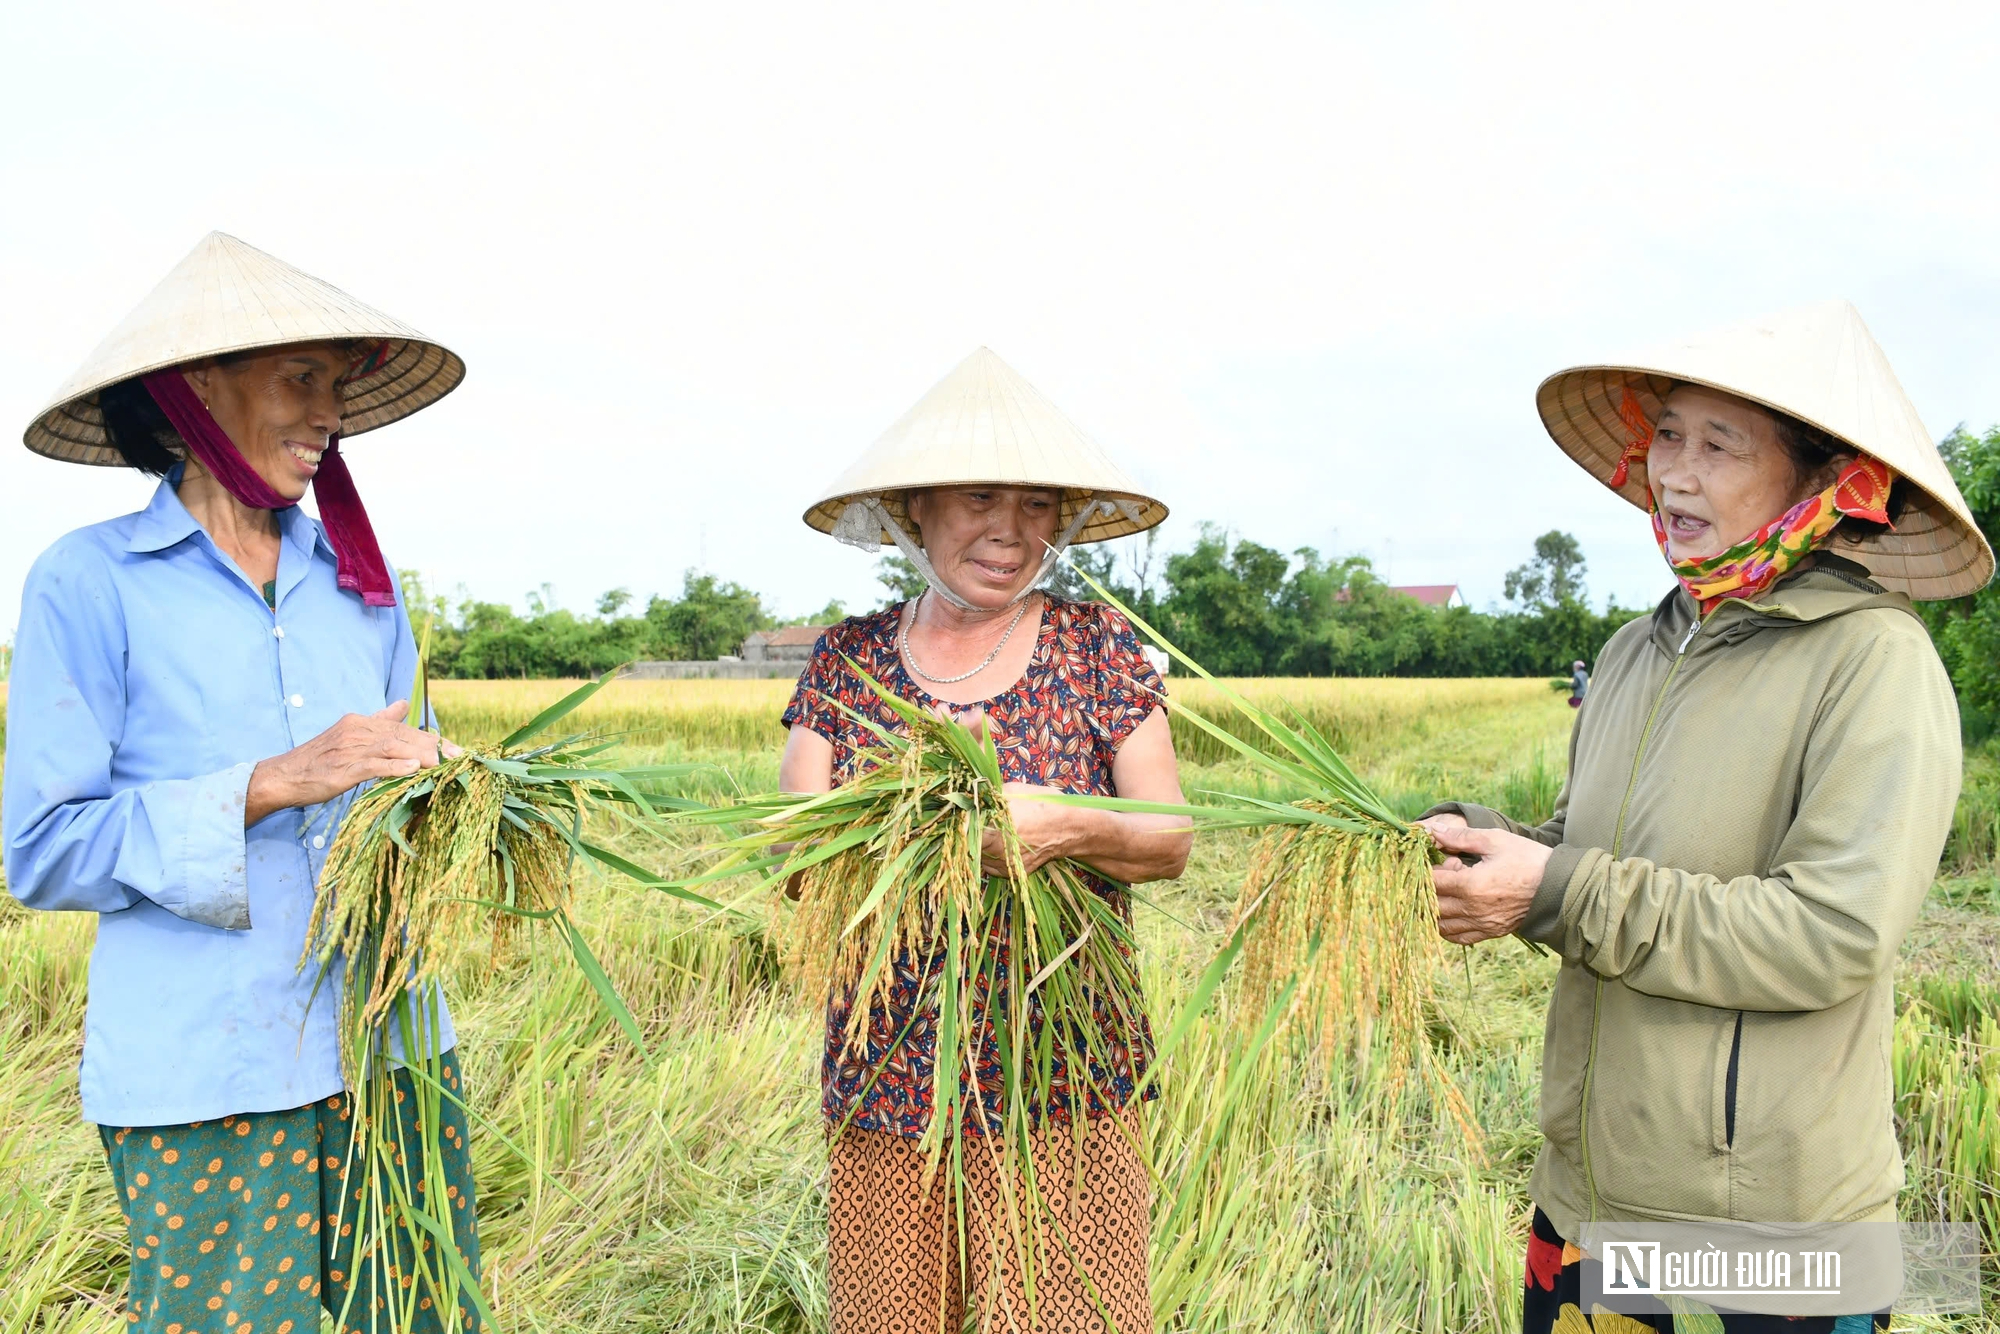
[{"xmin": 1424, "ymin": 302, "xmax": 1994, "ymax": 1334}]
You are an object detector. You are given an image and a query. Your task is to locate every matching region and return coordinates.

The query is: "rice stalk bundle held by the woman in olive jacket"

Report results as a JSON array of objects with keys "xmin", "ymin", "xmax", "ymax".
[{"xmin": 1058, "ymin": 570, "xmax": 1478, "ymax": 1142}]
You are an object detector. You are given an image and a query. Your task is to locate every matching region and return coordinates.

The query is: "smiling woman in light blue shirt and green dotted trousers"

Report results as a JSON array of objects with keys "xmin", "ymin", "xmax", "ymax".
[{"xmin": 4, "ymin": 232, "xmax": 478, "ymax": 1334}]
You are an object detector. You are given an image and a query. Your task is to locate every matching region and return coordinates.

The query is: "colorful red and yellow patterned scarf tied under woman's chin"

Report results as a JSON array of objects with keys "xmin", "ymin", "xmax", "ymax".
[{"xmin": 1612, "ymin": 390, "xmax": 1896, "ymax": 616}]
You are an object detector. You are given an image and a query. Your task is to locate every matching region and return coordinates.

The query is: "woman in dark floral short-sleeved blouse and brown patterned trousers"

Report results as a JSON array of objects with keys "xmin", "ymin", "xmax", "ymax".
[{"xmin": 780, "ymin": 348, "xmax": 1190, "ymax": 1334}]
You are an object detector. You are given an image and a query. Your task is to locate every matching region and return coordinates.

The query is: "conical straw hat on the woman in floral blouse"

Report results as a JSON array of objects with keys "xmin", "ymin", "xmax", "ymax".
[{"xmin": 806, "ymin": 348, "xmax": 1166, "ymax": 546}]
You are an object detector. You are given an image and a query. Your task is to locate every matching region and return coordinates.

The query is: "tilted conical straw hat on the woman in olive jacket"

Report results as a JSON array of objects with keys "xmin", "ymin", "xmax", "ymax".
[{"xmin": 1534, "ymin": 300, "xmax": 1994, "ymax": 600}]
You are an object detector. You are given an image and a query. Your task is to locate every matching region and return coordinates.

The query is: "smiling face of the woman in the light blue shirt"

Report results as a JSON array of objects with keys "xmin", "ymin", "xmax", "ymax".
[{"xmin": 184, "ymin": 342, "xmax": 348, "ymax": 500}]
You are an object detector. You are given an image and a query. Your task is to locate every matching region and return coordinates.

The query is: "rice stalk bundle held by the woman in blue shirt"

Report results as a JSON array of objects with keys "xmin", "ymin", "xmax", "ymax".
[{"xmin": 300, "ymin": 672, "xmax": 714, "ymax": 1330}]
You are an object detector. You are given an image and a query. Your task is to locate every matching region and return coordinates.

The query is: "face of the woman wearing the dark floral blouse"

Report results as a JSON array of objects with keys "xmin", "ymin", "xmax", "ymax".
[{"xmin": 908, "ymin": 486, "xmax": 1062, "ymax": 608}]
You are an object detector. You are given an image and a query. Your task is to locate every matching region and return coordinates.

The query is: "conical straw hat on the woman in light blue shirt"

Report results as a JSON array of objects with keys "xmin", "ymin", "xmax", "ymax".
[{"xmin": 24, "ymin": 232, "xmax": 466, "ymax": 464}]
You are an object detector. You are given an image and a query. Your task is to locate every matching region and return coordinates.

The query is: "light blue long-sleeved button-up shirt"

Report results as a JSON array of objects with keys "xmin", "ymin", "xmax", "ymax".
[{"xmin": 0, "ymin": 476, "xmax": 452, "ymax": 1126}]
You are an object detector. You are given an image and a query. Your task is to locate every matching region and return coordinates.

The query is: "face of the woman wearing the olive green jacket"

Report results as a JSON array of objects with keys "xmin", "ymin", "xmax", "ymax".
[{"xmin": 1646, "ymin": 384, "xmax": 1824, "ymax": 560}]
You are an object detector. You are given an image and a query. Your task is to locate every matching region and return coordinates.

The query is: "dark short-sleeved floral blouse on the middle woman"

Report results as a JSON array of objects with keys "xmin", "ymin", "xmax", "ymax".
[{"xmin": 784, "ymin": 594, "xmax": 1166, "ymax": 1138}]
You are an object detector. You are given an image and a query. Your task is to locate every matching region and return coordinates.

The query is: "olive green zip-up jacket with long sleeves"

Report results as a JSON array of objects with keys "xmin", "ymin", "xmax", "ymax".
[{"xmin": 1458, "ymin": 556, "xmax": 1960, "ymax": 1236}]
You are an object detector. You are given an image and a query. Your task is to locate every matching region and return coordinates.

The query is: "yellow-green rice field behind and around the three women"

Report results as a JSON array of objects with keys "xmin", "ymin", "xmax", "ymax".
[{"xmin": 0, "ymin": 680, "xmax": 2000, "ymax": 1334}]
